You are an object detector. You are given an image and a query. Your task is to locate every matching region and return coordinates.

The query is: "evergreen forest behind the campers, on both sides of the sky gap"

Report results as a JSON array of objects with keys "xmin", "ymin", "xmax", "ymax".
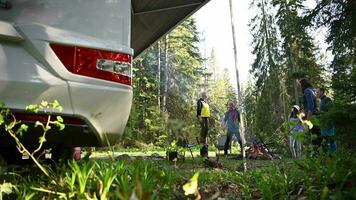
[{"xmin": 123, "ymin": 0, "xmax": 356, "ymax": 152}]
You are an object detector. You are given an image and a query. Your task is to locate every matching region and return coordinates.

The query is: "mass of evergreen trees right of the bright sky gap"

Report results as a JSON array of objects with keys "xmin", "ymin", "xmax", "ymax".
[{"xmin": 244, "ymin": 0, "xmax": 356, "ymax": 153}]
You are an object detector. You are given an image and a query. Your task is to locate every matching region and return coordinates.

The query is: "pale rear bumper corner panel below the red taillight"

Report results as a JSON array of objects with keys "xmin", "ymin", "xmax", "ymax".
[{"xmin": 69, "ymin": 82, "xmax": 132, "ymax": 146}]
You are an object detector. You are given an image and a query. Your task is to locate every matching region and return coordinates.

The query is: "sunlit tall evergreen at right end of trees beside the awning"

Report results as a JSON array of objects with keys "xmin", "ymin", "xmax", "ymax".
[{"xmin": 167, "ymin": 18, "xmax": 203, "ymax": 120}]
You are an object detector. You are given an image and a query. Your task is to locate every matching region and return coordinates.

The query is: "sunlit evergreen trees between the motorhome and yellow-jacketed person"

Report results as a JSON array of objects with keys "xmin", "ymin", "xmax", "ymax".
[{"xmin": 124, "ymin": 18, "xmax": 202, "ymax": 145}]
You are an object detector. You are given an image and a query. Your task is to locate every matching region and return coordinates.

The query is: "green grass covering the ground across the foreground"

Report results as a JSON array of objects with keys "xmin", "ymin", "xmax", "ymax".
[{"xmin": 0, "ymin": 148, "xmax": 356, "ymax": 199}]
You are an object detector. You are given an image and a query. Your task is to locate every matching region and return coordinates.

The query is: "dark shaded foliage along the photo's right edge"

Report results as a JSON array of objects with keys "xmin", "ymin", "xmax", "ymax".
[{"xmin": 306, "ymin": 0, "xmax": 356, "ymax": 150}]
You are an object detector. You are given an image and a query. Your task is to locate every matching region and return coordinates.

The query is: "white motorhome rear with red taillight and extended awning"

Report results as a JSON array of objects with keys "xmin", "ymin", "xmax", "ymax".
[{"xmin": 0, "ymin": 0, "xmax": 208, "ymax": 162}]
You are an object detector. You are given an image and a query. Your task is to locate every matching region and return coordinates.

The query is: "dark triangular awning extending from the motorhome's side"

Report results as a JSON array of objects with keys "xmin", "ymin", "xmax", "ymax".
[{"xmin": 131, "ymin": 0, "xmax": 209, "ymax": 57}]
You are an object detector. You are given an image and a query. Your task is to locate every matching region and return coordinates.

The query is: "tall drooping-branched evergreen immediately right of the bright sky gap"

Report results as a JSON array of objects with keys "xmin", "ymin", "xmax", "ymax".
[{"xmin": 244, "ymin": 0, "xmax": 289, "ymax": 145}]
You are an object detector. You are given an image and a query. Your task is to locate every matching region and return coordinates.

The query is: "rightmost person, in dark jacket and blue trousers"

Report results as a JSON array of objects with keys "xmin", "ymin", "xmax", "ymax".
[{"xmin": 315, "ymin": 88, "xmax": 336, "ymax": 152}]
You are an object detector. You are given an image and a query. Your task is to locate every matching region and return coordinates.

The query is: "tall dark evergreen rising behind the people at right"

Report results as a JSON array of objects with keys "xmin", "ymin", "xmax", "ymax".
[{"xmin": 273, "ymin": 0, "xmax": 325, "ymax": 104}]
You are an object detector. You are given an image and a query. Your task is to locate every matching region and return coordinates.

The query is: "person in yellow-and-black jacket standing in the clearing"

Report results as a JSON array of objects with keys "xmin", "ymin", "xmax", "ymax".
[{"xmin": 197, "ymin": 92, "xmax": 210, "ymax": 144}]
